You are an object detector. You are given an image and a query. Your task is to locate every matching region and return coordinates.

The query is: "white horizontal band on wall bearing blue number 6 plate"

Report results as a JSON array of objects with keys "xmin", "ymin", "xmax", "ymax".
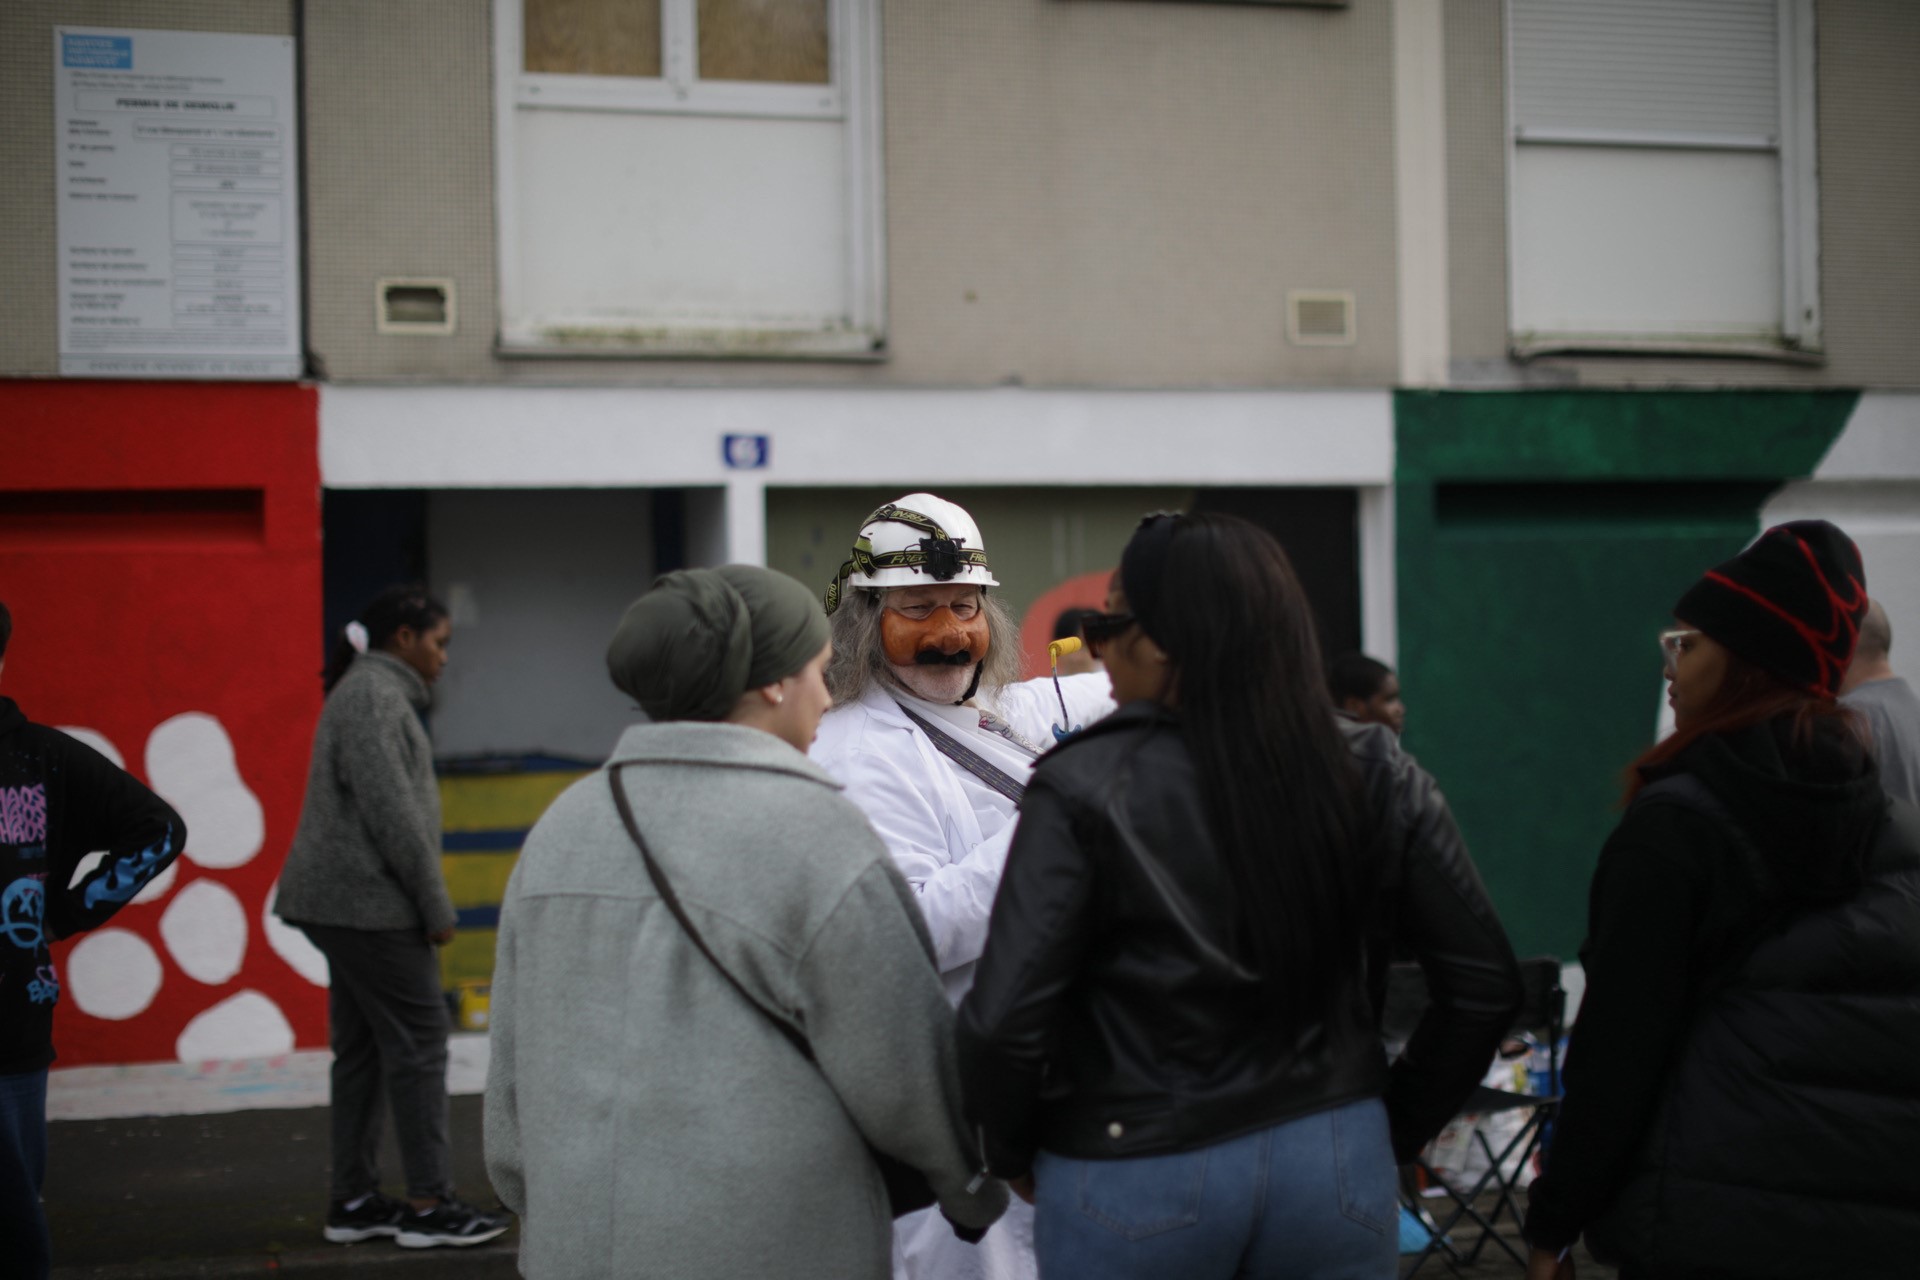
[{"xmin": 321, "ymin": 386, "xmax": 1394, "ymax": 487}]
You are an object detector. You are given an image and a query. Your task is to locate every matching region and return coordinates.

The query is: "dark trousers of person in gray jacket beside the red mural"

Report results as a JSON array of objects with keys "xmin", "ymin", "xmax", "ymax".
[{"xmin": 301, "ymin": 925, "xmax": 453, "ymax": 1199}]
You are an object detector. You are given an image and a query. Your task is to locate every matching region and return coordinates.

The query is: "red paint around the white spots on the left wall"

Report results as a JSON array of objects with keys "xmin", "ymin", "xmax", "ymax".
[{"xmin": 0, "ymin": 382, "xmax": 326, "ymax": 1067}]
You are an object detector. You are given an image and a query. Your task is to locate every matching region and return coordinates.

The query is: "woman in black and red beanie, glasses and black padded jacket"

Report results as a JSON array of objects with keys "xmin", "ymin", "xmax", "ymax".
[{"xmin": 1526, "ymin": 520, "xmax": 1920, "ymax": 1280}]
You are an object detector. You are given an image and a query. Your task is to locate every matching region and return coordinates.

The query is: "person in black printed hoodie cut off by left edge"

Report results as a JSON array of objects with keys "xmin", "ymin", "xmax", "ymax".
[{"xmin": 0, "ymin": 603, "xmax": 186, "ymax": 1280}]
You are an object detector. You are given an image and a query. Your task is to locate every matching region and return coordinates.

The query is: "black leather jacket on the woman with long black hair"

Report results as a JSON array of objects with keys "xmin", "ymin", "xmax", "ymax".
[{"xmin": 958, "ymin": 702, "xmax": 1521, "ymax": 1176}]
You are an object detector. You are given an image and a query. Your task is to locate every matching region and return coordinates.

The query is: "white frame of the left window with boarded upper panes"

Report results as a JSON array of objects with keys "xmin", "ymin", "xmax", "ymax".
[{"xmin": 493, "ymin": 0, "xmax": 887, "ymax": 361}]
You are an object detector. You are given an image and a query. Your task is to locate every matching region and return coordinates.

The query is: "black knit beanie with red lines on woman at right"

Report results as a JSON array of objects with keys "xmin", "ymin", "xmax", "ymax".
[{"xmin": 1674, "ymin": 520, "xmax": 1866, "ymax": 699}]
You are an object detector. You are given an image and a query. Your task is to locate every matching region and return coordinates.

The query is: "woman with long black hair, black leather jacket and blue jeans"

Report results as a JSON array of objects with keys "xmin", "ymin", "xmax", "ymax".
[{"xmin": 960, "ymin": 514, "xmax": 1519, "ymax": 1280}]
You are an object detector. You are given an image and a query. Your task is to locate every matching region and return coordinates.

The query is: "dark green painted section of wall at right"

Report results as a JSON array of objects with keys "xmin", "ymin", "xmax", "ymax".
[{"xmin": 1394, "ymin": 391, "xmax": 1857, "ymax": 960}]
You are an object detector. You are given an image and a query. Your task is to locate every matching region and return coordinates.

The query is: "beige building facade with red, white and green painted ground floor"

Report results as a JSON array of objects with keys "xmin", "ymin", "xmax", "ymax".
[{"xmin": 0, "ymin": 0, "xmax": 1920, "ymax": 1061}]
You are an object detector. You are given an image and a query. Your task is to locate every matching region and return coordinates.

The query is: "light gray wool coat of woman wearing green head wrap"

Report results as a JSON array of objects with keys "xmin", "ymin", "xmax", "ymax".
[{"xmin": 486, "ymin": 722, "xmax": 1006, "ymax": 1280}]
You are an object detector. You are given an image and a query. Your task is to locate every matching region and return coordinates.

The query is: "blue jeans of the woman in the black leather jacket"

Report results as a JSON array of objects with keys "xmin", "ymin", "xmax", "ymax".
[{"xmin": 1033, "ymin": 1098, "xmax": 1400, "ymax": 1280}]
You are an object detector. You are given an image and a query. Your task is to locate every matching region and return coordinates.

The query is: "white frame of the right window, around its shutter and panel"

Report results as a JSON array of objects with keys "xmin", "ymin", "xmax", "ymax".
[{"xmin": 1501, "ymin": 0, "xmax": 1826, "ymax": 365}]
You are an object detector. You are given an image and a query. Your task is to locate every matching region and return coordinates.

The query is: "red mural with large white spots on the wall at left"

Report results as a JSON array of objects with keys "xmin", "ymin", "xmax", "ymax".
[{"xmin": 0, "ymin": 382, "xmax": 326, "ymax": 1067}]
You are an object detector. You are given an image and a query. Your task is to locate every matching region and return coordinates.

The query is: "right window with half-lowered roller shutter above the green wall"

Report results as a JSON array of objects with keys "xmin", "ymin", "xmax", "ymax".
[{"xmin": 1507, "ymin": 0, "xmax": 1820, "ymax": 355}]
